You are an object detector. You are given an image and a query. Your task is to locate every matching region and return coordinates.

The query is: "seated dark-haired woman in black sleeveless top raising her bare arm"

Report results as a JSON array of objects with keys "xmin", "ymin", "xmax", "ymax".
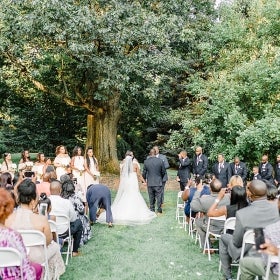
[{"xmin": 207, "ymin": 186, "xmax": 248, "ymax": 218}]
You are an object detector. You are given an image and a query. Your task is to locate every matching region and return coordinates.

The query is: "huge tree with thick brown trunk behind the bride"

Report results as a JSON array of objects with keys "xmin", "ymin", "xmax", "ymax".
[{"xmin": 0, "ymin": 0, "xmax": 217, "ymax": 170}]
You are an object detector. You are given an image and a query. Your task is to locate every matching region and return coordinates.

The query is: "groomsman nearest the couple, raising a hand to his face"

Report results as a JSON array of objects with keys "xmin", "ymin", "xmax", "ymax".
[{"xmin": 177, "ymin": 150, "xmax": 191, "ymax": 191}]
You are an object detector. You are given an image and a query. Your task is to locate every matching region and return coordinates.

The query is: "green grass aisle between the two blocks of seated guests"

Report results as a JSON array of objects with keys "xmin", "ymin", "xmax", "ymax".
[{"xmin": 60, "ymin": 191, "xmax": 223, "ymax": 280}]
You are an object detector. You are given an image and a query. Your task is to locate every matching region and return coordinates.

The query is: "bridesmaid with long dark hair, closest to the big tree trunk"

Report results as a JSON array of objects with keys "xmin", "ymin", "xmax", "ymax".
[{"xmin": 84, "ymin": 147, "xmax": 100, "ymax": 188}]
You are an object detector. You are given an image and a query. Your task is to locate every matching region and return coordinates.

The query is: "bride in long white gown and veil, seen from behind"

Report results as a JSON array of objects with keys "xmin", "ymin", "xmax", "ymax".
[{"xmin": 98, "ymin": 151, "xmax": 156, "ymax": 225}]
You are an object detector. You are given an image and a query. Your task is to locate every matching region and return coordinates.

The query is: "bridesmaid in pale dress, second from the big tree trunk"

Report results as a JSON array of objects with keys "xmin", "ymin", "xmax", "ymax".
[{"xmin": 71, "ymin": 146, "xmax": 86, "ymax": 199}]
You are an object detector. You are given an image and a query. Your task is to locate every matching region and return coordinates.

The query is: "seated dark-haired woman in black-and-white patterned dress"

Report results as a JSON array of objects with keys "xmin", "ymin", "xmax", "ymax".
[{"xmin": 61, "ymin": 180, "xmax": 91, "ymax": 245}]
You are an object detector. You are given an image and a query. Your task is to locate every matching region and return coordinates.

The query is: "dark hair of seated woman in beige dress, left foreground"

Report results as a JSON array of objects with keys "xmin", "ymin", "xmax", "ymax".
[{"xmin": 17, "ymin": 179, "xmax": 37, "ymax": 205}]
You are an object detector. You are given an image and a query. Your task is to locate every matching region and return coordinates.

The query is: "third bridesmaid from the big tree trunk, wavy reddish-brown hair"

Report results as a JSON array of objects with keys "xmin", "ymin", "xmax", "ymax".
[{"xmin": 53, "ymin": 145, "xmax": 71, "ymax": 180}]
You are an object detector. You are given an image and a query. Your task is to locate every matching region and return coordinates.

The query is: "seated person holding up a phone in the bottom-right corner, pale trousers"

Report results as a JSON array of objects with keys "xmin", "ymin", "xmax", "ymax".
[{"xmin": 239, "ymin": 221, "xmax": 280, "ymax": 280}]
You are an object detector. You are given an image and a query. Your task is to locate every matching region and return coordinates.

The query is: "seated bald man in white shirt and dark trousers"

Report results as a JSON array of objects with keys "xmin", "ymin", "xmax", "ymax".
[{"xmin": 50, "ymin": 180, "xmax": 83, "ymax": 257}]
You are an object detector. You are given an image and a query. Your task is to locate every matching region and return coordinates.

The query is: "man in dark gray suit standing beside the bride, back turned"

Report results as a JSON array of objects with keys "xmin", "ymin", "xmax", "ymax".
[{"xmin": 142, "ymin": 149, "xmax": 166, "ymax": 213}]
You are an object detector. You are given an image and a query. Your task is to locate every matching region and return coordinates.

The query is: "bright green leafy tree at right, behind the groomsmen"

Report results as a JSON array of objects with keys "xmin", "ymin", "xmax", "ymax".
[{"xmin": 168, "ymin": 0, "xmax": 280, "ymax": 164}]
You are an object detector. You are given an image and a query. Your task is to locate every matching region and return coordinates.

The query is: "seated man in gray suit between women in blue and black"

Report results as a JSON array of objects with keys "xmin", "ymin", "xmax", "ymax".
[{"xmin": 191, "ymin": 179, "xmax": 229, "ymax": 250}]
